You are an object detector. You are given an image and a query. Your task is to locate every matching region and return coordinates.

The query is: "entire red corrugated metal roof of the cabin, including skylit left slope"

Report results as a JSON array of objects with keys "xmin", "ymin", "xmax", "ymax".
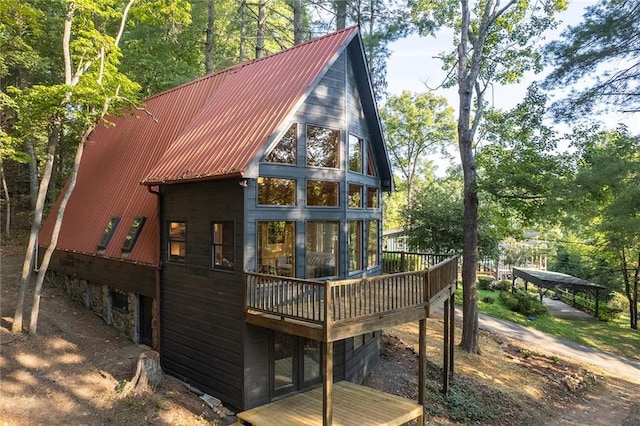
[{"xmin": 39, "ymin": 27, "xmax": 357, "ymax": 264}]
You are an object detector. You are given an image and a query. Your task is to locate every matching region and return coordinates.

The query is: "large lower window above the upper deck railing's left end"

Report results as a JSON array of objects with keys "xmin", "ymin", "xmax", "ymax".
[{"xmin": 258, "ymin": 221, "xmax": 296, "ymax": 277}]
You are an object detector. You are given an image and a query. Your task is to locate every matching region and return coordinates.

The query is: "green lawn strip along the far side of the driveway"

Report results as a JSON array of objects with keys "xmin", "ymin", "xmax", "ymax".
[{"xmin": 456, "ymin": 286, "xmax": 640, "ymax": 361}]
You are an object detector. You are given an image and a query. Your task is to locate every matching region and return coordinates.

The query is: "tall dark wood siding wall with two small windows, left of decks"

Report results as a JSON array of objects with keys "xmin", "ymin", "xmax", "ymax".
[{"xmin": 160, "ymin": 179, "xmax": 245, "ymax": 408}]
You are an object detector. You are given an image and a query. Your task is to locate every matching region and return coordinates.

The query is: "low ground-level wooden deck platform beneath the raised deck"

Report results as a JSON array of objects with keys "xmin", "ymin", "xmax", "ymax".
[{"xmin": 237, "ymin": 382, "xmax": 422, "ymax": 426}]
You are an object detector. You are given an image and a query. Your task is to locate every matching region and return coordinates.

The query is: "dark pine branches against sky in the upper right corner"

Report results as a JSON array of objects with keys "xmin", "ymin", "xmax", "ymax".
[{"xmin": 546, "ymin": 0, "xmax": 640, "ymax": 120}]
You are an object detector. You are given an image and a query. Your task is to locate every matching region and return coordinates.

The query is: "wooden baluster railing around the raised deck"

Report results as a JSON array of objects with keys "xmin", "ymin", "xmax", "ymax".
[{"xmin": 246, "ymin": 257, "xmax": 458, "ymax": 324}]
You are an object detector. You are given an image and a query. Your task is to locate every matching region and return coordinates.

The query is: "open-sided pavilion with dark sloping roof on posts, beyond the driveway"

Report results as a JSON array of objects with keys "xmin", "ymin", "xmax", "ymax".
[{"xmin": 512, "ymin": 268, "xmax": 606, "ymax": 318}]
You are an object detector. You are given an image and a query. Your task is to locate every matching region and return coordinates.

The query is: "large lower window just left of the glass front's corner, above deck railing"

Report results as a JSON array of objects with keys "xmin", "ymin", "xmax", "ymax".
[{"xmin": 306, "ymin": 222, "xmax": 338, "ymax": 278}]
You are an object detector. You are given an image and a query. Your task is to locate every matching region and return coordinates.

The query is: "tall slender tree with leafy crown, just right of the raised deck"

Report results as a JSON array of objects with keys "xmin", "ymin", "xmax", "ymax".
[{"xmin": 412, "ymin": 0, "xmax": 566, "ymax": 353}]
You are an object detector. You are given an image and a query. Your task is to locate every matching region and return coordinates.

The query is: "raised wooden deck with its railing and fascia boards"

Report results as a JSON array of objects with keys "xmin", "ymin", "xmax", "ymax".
[{"xmin": 245, "ymin": 257, "xmax": 458, "ymax": 342}]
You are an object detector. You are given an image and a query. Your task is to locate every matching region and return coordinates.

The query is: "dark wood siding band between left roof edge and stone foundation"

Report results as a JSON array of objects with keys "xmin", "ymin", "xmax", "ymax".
[{"xmin": 49, "ymin": 250, "xmax": 156, "ymax": 298}]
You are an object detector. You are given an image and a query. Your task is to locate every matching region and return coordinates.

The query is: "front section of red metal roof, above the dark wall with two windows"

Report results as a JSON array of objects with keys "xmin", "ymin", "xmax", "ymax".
[{"xmin": 144, "ymin": 27, "xmax": 357, "ymax": 184}]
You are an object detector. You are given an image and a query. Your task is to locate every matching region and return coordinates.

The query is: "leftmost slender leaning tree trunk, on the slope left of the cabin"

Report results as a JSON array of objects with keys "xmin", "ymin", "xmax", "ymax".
[{"xmin": 11, "ymin": 125, "xmax": 61, "ymax": 333}]
